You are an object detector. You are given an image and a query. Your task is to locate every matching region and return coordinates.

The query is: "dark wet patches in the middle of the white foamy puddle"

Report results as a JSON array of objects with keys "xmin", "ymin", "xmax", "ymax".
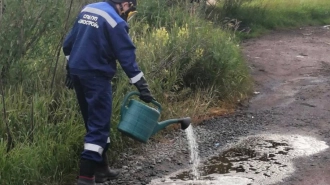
[{"xmin": 170, "ymin": 140, "xmax": 293, "ymax": 180}]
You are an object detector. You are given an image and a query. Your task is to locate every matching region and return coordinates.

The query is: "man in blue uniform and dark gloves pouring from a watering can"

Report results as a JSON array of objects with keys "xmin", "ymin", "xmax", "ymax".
[{"xmin": 63, "ymin": 0, "xmax": 154, "ymax": 185}]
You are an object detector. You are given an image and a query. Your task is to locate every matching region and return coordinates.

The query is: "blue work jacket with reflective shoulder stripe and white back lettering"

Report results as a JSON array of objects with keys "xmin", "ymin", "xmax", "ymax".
[{"xmin": 63, "ymin": 2, "xmax": 143, "ymax": 83}]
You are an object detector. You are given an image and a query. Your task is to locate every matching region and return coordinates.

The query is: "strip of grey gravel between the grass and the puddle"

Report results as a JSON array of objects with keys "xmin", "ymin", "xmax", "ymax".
[{"xmin": 98, "ymin": 107, "xmax": 271, "ymax": 185}]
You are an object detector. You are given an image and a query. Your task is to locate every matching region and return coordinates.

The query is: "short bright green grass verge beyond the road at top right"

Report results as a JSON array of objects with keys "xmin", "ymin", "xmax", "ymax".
[{"xmin": 211, "ymin": 0, "xmax": 330, "ymax": 38}]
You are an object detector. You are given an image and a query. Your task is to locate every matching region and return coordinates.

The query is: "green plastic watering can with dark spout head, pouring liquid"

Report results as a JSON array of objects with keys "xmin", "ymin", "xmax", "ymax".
[{"xmin": 118, "ymin": 91, "xmax": 191, "ymax": 143}]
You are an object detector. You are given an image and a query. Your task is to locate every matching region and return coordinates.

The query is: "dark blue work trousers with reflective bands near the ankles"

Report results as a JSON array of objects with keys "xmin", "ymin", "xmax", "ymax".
[{"xmin": 71, "ymin": 75, "xmax": 112, "ymax": 162}]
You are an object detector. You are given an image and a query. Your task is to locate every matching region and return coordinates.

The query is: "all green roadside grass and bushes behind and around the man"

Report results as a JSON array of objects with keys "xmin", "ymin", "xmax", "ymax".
[{"xmin": 0, "ymin": 0, "xmax": 330, "ymax": 185}]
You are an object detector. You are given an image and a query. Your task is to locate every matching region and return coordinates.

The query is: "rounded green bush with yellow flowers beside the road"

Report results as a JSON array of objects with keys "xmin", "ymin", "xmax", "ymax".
[{"xmin": 130, "ymin": 20, "xmax": 251, "ymax": 101}]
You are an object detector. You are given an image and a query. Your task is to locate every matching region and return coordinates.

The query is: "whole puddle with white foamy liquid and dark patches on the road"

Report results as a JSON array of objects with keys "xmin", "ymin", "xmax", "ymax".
[{"xmin": 150, "ymin": 135, "xmax": 328, "ymax": 185}]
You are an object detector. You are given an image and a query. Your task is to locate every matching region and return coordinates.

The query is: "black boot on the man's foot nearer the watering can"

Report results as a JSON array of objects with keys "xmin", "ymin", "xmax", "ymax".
[{"xmin": 95, "ymin": 153, "xmax": 120, "ymax": 183}]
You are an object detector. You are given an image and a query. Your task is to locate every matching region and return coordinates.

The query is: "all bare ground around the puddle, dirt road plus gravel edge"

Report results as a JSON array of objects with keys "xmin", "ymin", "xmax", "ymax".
[{"xmin": 102, "ymin": 26, "xmax": 330, "ymax": 185}]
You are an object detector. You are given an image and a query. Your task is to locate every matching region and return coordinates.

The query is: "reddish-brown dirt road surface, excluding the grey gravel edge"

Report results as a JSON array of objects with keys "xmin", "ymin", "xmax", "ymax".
[{"xmin": 243, "ymin": 27, "xmax": 330, "ymax": 185}]
